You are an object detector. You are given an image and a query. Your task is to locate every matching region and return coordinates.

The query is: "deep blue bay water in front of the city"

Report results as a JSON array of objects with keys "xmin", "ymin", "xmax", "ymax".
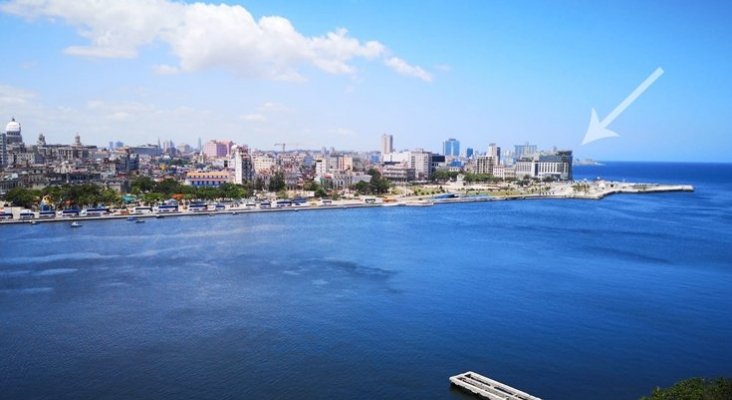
[{"xmin": 0, "ymin": 163, "xmax": 732, "ymax": 400}]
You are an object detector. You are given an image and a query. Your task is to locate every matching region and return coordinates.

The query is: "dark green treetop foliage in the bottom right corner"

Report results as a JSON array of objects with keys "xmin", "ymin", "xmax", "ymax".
[{"xmin": 640, "ymin": 378, "xmax": 732, "ymax": 400}]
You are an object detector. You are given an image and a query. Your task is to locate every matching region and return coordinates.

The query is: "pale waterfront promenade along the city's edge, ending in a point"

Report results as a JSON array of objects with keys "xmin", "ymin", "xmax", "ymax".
[{"xmin": 0, "ymin": 181, "xmax": 694, "ymax": 225}]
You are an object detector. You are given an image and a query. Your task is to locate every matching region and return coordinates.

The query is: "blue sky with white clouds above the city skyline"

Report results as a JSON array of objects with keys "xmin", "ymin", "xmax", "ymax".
[{"xmin": 0, "ymin": 0, "xmax": 732, "ymax": 162}]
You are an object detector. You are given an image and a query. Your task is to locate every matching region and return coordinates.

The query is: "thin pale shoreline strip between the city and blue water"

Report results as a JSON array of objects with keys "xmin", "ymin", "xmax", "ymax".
[{"xmin": 0, "ymin": 182, "xmax": 694, "ymax": 226}]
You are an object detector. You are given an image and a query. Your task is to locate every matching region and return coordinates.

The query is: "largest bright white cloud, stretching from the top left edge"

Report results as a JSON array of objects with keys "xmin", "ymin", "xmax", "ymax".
[{"xmin": 0, "ymin": 0, "xmax": 432, "ymax": 81}]
